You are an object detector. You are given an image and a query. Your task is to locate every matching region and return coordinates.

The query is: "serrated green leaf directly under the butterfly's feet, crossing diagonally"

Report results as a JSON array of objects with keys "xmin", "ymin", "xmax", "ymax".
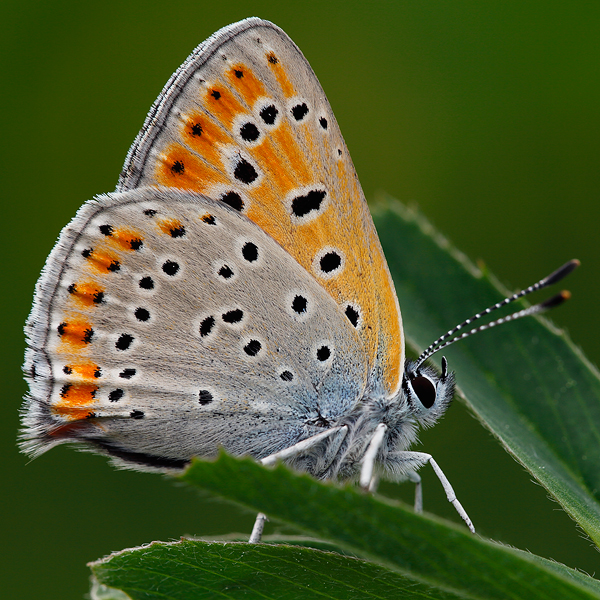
[{"xmin": 182, "ymin": 454, "xmax": 600, "ymax": 599}]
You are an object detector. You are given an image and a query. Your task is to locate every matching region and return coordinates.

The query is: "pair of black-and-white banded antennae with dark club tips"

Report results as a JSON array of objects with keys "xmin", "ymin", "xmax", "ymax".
[{"xmin": 416, "ymin": 259, "xmax": 581, "ymax": 368}]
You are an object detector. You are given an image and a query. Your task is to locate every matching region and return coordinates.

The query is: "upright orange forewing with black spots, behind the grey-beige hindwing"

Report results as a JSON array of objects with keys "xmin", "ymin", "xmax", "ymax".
[{"xmin": 117, "ymin": 18, "xmax": 404, "ymax": 397}]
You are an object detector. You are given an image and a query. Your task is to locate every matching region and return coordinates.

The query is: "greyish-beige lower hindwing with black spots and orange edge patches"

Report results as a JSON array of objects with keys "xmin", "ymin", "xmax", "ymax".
[{"xmin": 24, "ymin": 188, "xmax": 367, "ymax": 468}]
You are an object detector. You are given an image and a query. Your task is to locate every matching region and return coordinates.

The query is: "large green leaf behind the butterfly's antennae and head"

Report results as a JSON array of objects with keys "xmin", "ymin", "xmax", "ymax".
[{"xmin": 374, "ymin": 202, "xmax": 600, "ymax": 545}]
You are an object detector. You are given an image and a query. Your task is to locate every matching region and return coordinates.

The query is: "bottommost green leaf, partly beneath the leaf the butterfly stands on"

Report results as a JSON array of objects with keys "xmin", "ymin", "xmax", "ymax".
[{"xmin": 91, "ymin": 540, "xmax": 460, "ymax": 600}]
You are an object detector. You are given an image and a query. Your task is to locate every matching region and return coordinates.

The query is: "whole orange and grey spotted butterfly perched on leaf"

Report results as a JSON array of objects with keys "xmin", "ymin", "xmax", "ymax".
[{"xmin": 21, "ymin": 18, "xmax": 573, "ymax": 530}]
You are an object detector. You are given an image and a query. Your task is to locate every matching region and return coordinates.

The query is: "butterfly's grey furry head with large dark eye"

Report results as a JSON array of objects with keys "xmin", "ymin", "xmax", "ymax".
[{"xmin": 402, "ymin": 357, "xmax": 454, "ymax": 427}]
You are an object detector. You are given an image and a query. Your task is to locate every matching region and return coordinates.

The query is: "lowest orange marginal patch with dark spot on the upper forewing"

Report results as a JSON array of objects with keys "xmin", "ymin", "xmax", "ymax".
[{"xmin": 156, "ymin": 144, "xmax": 228, "ymax": 192}]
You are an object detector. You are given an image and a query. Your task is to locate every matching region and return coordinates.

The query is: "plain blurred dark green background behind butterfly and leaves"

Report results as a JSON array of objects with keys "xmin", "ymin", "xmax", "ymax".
[{"xmin": 0, "ymin": 0, "xmax": 600, "ymax": 600}]
